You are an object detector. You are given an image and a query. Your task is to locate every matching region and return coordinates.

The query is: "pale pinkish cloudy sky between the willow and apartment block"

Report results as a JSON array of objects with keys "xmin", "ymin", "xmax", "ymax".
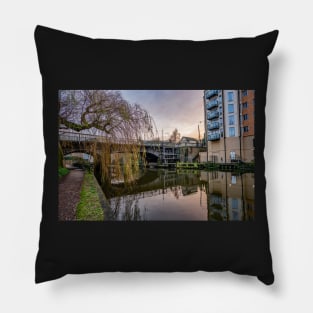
[{"xmin": 120, "ymin": 90, "xmax": 204, "ymax": 140}]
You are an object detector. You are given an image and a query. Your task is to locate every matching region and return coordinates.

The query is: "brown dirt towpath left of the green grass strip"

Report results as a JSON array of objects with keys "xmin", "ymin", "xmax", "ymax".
[{"xmin": 59, "ymin": 170, "xmax": 84, "ymax": 221}]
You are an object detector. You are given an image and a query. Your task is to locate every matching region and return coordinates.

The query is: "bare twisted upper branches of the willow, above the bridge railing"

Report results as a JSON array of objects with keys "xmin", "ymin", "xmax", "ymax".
[{"xmin": 58, "ymin": 90, "xmax": 153, "ymax": 139}]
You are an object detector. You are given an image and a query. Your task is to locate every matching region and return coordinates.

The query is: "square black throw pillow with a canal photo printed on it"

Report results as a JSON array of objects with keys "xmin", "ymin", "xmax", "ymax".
[{"xmin": 35, "ymin": 26, "xmax": 278, "ymax": 285}]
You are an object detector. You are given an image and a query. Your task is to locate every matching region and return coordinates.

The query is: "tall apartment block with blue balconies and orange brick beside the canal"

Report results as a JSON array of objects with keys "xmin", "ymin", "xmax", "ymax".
[{"xmin": 204, "ymin": 90, "xmax": 255, "ymax": 163}]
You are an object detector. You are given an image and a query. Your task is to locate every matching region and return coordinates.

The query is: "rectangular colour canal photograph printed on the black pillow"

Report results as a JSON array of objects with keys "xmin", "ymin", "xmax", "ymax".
[{"xmin": 57, "ymin": 90, "xmax": 256, "ymax": 222}]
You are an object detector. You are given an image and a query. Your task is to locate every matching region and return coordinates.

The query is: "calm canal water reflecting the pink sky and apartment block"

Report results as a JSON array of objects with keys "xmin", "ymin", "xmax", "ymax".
[{"xmin": 103, "ymin": 170, "xmax": 254, "ymax": 221}]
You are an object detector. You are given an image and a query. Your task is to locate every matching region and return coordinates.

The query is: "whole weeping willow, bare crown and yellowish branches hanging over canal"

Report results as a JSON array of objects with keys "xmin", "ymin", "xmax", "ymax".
[{"xmin": 58, "ymin": 90, "xmax": 154, "ymax": 189}]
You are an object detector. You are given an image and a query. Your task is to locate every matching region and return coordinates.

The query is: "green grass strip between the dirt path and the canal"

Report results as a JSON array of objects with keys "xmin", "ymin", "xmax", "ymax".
[{"xmin": 76, "ymin": 172, "xmax": 104, "ymax": 221}]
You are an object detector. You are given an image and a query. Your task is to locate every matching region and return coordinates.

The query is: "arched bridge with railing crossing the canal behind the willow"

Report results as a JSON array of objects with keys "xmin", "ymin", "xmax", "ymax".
[{"xmin": 59, "ymin": 131, "xmax": 180, "ymax": 163}]
